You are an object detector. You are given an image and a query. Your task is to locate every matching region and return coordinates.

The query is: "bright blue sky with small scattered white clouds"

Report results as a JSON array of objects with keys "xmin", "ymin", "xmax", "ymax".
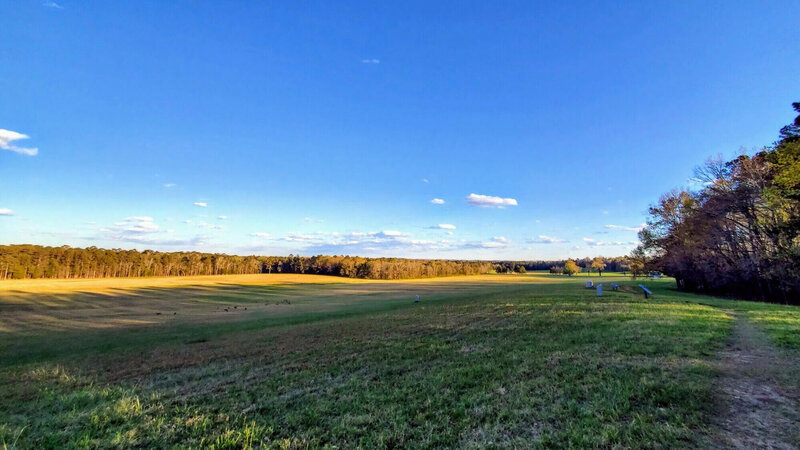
[{"xmin": 0, "ymin": 0, "xmax": 800, "ymax": 259}]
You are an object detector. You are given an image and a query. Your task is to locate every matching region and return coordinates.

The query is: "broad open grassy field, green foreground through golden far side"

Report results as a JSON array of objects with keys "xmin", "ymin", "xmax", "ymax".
[{"xmin": 0, "ymin": 274, "xmax": 800, "ymax": 448}]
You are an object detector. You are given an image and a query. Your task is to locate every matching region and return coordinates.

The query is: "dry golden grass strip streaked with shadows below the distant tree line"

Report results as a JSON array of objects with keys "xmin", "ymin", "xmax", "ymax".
[{"xmin": 0, "ymin": 274, "xmax": 572, "ymax": 333}]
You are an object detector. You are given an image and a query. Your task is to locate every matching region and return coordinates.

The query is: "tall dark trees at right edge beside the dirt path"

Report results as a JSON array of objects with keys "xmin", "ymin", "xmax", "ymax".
[{"xmin": 631, "ymin": 102, "xmax": 800, "ymax": 304}]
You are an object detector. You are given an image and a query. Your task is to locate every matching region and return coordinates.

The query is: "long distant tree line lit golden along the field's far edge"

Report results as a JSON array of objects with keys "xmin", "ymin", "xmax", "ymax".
[{"xmin": 0, "ymin": 245, "xmax": 627, "ymax": 280}]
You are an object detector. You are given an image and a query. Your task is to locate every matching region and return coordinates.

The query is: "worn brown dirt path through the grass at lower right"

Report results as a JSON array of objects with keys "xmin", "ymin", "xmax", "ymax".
[{"xmin": 710, "ymin": 314, "xmax": 800, "ymax": 449}]
